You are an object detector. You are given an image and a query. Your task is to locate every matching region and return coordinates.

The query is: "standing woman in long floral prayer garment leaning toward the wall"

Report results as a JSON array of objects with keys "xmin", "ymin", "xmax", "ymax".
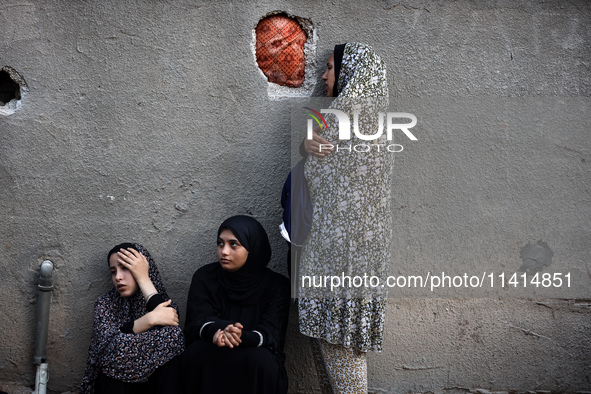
[{"xmin": 298, "ymin": 43, "xmax": 393, "ymax": 393}]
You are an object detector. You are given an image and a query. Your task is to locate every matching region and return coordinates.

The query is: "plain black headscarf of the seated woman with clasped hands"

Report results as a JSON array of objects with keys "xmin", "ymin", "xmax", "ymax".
[{"xmin": 218, "ymin": 215, "xmax": 271, "ymax": 305}]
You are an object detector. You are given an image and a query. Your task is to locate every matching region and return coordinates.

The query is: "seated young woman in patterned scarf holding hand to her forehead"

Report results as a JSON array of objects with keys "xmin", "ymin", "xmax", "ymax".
[{"xmin": 80, "ymin": 243, "xmax": 184, "ymax": 394}]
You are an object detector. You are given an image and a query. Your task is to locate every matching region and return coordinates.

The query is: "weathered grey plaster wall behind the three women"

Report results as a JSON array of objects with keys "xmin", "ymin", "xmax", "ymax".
[{"xmin": 0, "ymin": 0, "xmax": 591, "ymax": 393}]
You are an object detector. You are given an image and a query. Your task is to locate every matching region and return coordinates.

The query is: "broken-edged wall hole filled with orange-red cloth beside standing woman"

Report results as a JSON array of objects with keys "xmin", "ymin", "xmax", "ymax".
[{"xmin": 253, "ymin": 11, "xmax": 315, "ymax": 96}]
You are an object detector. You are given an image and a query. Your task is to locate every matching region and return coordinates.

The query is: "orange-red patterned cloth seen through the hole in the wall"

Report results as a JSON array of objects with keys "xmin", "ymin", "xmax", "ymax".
[{"xmin": 256, "ymin": 14, "xmax": 307, "ymax": 88}]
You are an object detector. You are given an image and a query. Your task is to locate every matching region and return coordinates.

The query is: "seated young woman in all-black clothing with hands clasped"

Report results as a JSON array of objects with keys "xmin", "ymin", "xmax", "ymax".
[{"xmin": 183, "ymin": 216, "xmax": 290, "ymax": 394}]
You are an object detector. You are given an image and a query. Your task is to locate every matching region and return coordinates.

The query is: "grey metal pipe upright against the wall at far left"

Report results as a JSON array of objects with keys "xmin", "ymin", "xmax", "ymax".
[{"xmin": 33, "ymin": 260, "xmax": 53, "ymax": 394}]
